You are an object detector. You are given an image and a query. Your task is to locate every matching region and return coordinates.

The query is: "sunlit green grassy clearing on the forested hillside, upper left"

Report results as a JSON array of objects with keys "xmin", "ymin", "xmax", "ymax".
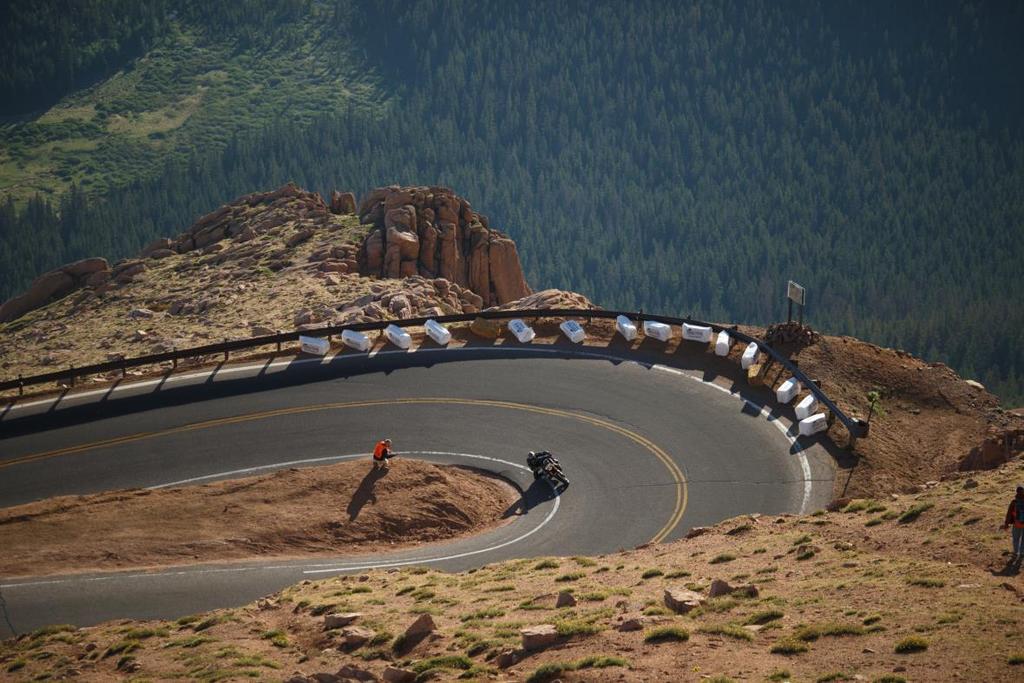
[{"xmin": 0, "ymin": 2, "xmax": 383, "ymax": 204}]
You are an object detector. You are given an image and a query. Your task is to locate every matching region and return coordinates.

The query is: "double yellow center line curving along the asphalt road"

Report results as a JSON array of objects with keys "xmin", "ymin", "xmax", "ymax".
[{"xmin": 0, "ymin": 398, "xmax": 687, "ymax": 543}]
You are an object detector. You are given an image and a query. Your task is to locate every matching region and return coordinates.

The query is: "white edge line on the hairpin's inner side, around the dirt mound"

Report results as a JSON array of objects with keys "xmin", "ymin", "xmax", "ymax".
[{"xmin": 0, "ymin": 451, "xmax": 561, "ymax": 589}]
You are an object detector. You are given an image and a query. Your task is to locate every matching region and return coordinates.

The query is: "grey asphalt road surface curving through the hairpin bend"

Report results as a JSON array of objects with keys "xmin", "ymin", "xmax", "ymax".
[{"xmin": 0, "ymin": 345, "xmax": 835, "ymax": 636}]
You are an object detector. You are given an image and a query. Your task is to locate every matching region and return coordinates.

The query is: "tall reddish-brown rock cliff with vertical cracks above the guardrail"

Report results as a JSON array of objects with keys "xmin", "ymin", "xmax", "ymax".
[{"xmin": 358, "ymin": 185, "xmax": 530, "ymax": 306}]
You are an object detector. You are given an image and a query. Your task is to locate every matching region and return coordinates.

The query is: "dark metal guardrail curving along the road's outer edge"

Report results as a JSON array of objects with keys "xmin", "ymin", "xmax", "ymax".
[{"xmin": 0, "ymin": 308, "xmax": 867, "ymax": 438}]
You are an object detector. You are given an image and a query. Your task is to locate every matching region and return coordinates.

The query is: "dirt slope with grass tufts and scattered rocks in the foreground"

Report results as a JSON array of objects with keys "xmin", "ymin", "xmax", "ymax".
[{"xmin": 0, "ymin": 461, "xmax": 1024, "ymax": 683}]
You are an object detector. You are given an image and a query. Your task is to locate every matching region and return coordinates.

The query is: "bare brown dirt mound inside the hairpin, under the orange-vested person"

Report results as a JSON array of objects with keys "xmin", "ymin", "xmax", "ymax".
[{"xmin": 0, "ymin": 458, "xmax": 518, "ymax": 578}]
